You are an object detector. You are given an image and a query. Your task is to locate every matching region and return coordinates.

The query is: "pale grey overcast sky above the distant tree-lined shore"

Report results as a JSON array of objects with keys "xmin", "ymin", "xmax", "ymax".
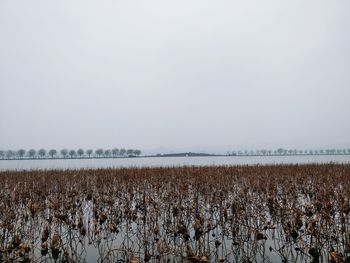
[{"xmin": 0, "ymin": 0, "xmax": 350, "ymax": 152}]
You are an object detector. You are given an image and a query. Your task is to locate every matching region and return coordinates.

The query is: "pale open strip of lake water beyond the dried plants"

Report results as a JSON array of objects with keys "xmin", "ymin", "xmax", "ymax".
[{"xmin": 0, "ymin": 155, "xmax": 350, "ymax": 170}]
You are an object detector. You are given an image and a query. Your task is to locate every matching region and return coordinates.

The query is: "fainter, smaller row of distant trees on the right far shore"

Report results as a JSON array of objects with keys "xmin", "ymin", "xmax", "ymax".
[{"xmin": 227, "ymin": 148, "xmax": 350, "ymax": 156}]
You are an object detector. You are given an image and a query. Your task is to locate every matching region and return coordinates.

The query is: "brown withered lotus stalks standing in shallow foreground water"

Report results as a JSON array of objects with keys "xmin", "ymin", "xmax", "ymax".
[{"xmin": 0, "ymin": 164, "xmax": 350, "ymax": 263}]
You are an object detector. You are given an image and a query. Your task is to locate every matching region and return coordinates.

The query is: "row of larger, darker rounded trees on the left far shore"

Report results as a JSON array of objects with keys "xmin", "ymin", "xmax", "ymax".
[{"xmin": 0, "ymin": 148, "xmax": 141, "ymax": 159}]
